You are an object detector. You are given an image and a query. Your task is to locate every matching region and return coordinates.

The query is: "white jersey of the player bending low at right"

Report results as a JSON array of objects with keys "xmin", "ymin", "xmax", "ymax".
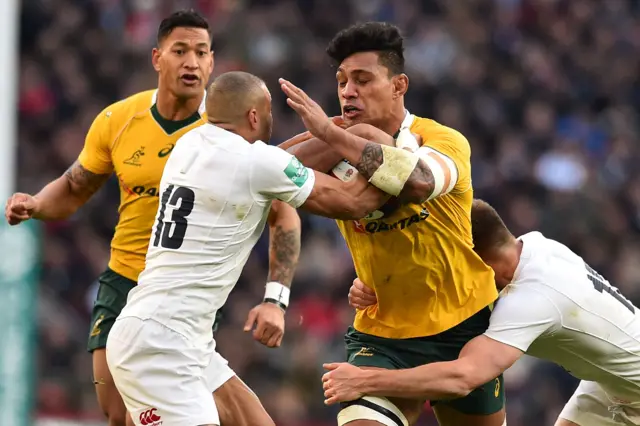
[{"xmin": 485, "ymin": 232, "xmax": 640, "ymax": 402}]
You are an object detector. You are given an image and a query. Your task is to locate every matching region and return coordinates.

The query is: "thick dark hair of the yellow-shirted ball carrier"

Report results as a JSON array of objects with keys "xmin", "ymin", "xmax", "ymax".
[{"xmin": 327, "ymin": 22, "xmax": 404, "ymax": 75}]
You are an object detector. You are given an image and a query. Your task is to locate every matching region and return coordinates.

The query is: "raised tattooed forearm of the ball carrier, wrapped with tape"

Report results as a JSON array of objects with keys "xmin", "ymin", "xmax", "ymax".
[{"xmin": 325, "ymin": 126, "xmax": 435, "ymax": 203}]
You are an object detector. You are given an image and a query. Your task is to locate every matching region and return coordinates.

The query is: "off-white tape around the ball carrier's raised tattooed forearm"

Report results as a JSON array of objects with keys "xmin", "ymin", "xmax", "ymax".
[{"xmin": 369, "ymin": 145, "xmax": 420, "ymax": 196}]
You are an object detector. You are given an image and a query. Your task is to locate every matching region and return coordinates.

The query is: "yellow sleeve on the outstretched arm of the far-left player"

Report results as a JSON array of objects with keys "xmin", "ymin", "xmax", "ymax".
[{"xmin": 78, "ymin": 108, "xmax": 113, "ymax": 175}]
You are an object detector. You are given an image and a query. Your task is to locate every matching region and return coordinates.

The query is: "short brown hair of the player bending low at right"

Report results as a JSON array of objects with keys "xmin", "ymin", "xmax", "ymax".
[{"xmin": 471, "ymin": 200, "xmax": 513, "ymax": 259}]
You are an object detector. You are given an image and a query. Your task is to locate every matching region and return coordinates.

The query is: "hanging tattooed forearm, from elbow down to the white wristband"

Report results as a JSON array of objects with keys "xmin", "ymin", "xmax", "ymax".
[{"xmin": 269, "ymin": 203, "xmax": 301, "ymax": 287}]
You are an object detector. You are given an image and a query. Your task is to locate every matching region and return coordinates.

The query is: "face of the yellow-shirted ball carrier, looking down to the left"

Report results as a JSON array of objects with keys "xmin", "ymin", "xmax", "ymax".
[{"xmin": 336, "ymin": 52, "xmax": 399, "ymax": 126}]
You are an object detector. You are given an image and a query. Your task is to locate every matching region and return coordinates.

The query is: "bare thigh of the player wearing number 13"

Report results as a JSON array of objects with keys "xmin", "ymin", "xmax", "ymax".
[{"xmin": 213, "ymin": 376, "xmax": 275, "ymax": 426}]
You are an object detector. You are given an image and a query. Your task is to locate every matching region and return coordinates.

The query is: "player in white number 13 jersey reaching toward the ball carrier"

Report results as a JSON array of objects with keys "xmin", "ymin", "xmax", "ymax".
[{"xmin": 107, "ymin": 72, "xmax": 388, "ymax": 426}]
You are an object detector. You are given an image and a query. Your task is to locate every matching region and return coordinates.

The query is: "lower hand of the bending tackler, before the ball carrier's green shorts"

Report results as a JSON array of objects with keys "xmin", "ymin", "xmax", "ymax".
[{"xmin": 322, "ymin": 362, "xmax": 366, "ymax": 405}]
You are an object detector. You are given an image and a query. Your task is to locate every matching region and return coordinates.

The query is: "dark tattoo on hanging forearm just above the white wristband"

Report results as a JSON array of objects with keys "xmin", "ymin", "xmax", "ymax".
[{"xmin": 269, "ymin": 226, "xmax": 300, "ymax": 287}]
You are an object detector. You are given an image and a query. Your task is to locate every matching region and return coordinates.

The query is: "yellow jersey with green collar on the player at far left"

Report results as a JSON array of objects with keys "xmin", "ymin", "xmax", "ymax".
[{"xmin": 78, "ymin": 90, "xmax": 205, "ymax": 281}]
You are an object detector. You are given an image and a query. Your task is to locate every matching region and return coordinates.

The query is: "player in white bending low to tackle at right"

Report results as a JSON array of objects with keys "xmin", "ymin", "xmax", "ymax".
[{"xmin": 322, "ymin": 200, "xmax": 640, "ymax": 426}]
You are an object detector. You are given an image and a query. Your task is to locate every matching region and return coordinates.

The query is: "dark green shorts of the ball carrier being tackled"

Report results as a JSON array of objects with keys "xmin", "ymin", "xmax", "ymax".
[{"xmin": 345, "ymin": 307, "xmax": 505, "ymax": 415}]
